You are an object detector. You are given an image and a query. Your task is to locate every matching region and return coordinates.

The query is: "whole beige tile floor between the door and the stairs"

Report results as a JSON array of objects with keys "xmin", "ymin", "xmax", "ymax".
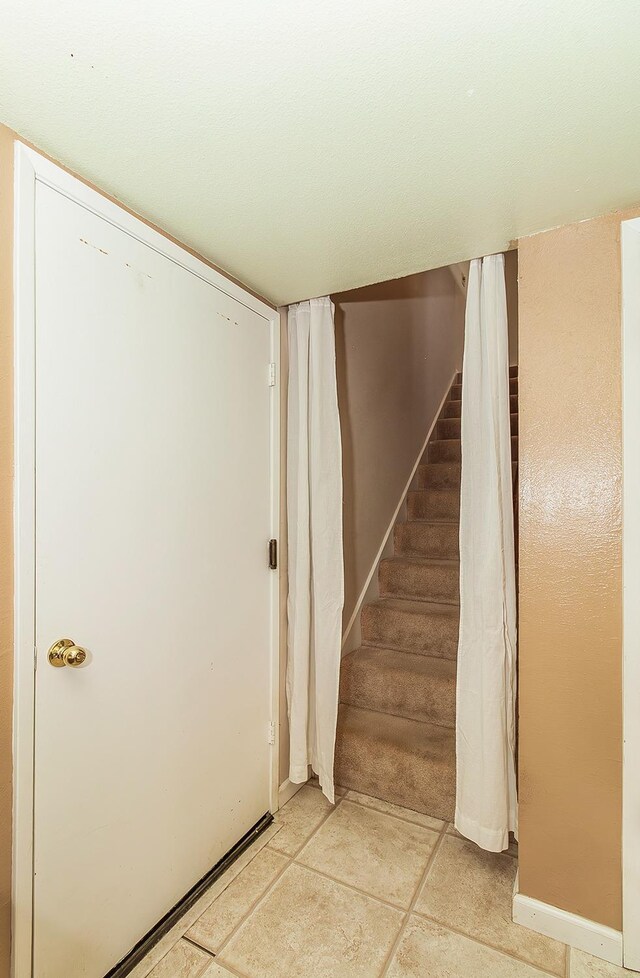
[{"xmin": 132, "ymin": 783, "xmax": 632, "ymax": 978}]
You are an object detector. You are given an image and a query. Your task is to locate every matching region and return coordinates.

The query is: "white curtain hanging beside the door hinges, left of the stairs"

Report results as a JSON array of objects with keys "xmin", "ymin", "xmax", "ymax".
[{"xmin": 287, "ymin": 297, "xmax": 344, "ymax": 803}]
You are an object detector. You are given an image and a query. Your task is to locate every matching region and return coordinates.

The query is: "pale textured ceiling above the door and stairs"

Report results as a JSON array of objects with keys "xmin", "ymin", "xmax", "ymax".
[{"xmin": 0, "ymin": 0, "xmax": 640, "ymax": 302}]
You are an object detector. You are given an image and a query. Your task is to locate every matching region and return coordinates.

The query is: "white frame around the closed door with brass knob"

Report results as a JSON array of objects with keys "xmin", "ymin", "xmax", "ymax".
[{"xmin": 12, "ymin": 143, "xmax": 280, "ymax": 978}]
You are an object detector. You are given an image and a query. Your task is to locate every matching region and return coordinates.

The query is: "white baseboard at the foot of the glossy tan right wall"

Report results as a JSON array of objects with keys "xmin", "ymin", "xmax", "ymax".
[{"xmin": 513, "ymin": 879, "xmax": 622, "ymax": 968}]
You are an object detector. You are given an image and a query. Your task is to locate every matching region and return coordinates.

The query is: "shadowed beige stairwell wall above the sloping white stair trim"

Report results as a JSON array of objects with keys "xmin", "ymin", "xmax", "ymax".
[{"xmin": 333, "ymin": 268, "xmax": 464, "ymax": 625}]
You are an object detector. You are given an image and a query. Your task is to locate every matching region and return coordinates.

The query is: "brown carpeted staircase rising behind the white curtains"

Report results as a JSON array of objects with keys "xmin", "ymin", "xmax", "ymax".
[{"xmin": 335, "ymin": 367, "xmax": 518, "ymax": 821}]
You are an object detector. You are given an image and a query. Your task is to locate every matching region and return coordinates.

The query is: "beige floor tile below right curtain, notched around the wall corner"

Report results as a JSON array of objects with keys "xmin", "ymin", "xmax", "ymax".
[{"xmin": 415, "ymin": 835, "xmax": 566, "ymax": 975}]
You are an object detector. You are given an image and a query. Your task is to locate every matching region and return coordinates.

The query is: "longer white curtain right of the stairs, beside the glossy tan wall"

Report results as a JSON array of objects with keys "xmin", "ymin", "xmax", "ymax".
[{"xmin": 455, "ymin": 255, "xmax": 517, "ymax": 852}]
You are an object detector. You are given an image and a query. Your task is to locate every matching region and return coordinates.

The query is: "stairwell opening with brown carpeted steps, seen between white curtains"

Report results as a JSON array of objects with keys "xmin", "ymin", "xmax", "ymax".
[{"xmin": 333, "ymin": 252, "xmax": 518, "ymax": 821}]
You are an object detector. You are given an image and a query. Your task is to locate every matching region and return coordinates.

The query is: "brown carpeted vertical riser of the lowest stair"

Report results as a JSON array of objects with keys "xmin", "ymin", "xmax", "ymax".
[{"xmin": 335, "ymin": 708, "xmax": 456, "ymax": 822}]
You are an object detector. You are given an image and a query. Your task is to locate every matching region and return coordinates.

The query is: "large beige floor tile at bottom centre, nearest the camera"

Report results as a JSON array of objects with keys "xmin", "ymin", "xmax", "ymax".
[{"xmin": 220, "ymin": 864, "xmax": 404, "ymax": 978}]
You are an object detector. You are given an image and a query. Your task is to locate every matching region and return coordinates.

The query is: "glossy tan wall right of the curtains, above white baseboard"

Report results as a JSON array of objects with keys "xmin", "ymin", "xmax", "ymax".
[{"xmin": 519, "ymin": 204, "xmax": 640, "ymax": 929}]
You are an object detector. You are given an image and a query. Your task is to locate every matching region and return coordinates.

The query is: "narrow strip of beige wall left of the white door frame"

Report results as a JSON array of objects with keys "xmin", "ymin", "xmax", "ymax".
[{"xmin": 0, "ymin": 126, "xmax": 13, "ymax": 978}]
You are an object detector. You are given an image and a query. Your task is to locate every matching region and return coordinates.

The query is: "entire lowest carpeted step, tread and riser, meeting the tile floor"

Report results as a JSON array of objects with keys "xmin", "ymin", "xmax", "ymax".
[{"xmin": 335, "ymin": 705, "xmax": 455, "ymax": 821}]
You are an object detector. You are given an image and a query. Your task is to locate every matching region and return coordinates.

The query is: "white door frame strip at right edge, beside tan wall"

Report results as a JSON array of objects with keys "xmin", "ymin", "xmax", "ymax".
[{"xmin": 621, "ymin": 219, "xmax": 640, "ymax": 971}]
